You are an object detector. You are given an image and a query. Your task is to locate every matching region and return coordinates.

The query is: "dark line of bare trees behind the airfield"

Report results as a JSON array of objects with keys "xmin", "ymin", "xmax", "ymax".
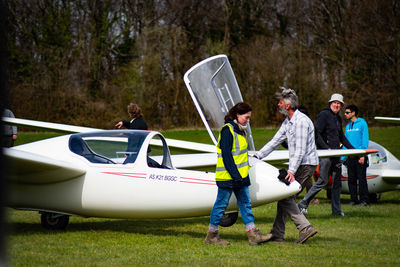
[{"xmin": 3, "ymin": 0, "xmax": 400, "ymax": 129}]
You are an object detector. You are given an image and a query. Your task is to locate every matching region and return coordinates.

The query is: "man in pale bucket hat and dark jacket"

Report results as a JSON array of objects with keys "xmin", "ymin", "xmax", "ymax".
[{"xmin": 298, "ymin": 94, "xmax": 354, "ymax": 217}]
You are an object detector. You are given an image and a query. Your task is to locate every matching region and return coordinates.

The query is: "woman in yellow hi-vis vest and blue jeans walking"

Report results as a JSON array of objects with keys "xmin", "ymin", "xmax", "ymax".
[{"xmin": 204, "ymin": 102, "xmax": 267, "ymax": 245}]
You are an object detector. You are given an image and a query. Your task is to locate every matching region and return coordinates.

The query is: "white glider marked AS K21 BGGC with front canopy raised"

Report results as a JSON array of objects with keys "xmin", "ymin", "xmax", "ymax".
[{"xmin": 3, "ymin": 55, "xmax": 390, "ymax": 229}]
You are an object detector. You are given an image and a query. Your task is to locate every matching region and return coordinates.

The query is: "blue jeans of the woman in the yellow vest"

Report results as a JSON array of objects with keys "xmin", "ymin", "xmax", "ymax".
[{"xmin": 210, "ymin": 186, "xmax": 254, "ymax": 228}]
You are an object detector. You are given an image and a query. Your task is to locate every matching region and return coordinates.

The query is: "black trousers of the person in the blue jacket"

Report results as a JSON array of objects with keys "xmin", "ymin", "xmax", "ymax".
[{"xmin": 347, "ymin": 158, "xmax": 369, "ymax": 203}]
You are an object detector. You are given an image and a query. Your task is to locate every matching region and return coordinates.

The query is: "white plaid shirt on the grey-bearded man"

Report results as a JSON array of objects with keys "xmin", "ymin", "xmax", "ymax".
[{"xmin": 256, "ymin": 110, "xmax": 319, "ymax": 174}]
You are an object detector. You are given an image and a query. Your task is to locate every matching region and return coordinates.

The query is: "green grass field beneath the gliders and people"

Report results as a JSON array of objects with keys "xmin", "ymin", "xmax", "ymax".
[{"xmin": 7, "ymin": 127, "xmax": 400, "ymax": 266}]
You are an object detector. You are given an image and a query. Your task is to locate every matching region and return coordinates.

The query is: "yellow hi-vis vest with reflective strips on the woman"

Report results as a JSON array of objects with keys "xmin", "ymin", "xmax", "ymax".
[{"xmin": 215, "ymin": 123, "xmax": 249, "ymax": 181}]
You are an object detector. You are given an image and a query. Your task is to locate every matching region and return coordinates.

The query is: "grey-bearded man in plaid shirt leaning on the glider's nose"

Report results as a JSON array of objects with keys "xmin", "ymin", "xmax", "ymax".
[{"xmin": 254, "ymin": 87, "xmax": 318, "ymax": 244}]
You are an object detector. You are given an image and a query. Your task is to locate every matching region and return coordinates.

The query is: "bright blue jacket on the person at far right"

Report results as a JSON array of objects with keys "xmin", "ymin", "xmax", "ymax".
[{"xmin": 344, "ymin": 118, "xmax": 369, "ymax": 149}]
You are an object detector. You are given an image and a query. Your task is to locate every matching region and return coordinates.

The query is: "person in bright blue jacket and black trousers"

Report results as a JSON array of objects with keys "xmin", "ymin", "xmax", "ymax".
[{"xmin": 343, "ymin": 105, "xmax": 369, "ymax": 206}]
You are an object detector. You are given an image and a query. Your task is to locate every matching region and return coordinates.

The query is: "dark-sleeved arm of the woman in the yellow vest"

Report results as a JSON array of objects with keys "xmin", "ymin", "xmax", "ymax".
[{"xmin": 219, "ymin": 127, "xmax": 244, "ymax": 180}]
